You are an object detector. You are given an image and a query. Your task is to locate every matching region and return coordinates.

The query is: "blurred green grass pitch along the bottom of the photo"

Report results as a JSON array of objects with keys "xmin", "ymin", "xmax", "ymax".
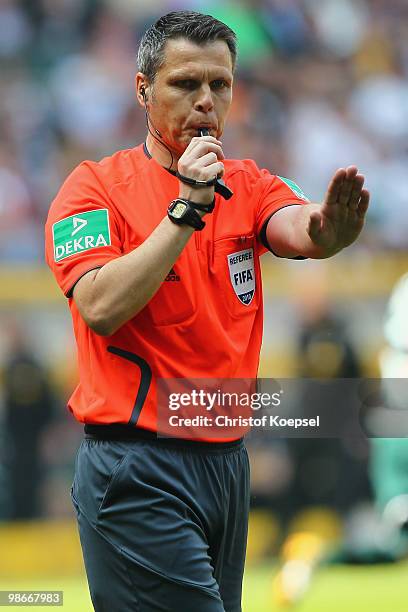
[{"xmin": 0, "ymin": 562, "xmax": 408, "ymax": 612}]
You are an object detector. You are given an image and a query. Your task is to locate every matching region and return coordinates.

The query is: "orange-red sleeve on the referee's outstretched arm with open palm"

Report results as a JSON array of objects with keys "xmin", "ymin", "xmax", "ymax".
[{"xmin": 255, "ymin": 170, "xmax": 309, "ymax": 254}]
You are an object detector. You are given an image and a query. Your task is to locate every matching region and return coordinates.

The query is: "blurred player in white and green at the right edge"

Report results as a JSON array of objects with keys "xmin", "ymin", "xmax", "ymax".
[{"xmin": 330, "ymin": 275, "xmax": 408, "ymax": 563}]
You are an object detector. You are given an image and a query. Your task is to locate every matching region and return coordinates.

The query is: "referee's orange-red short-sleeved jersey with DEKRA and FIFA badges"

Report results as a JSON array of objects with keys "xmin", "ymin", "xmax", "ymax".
[{"xmin": 46, "ymin": 145, "xmax": 306, "ymax": 431}]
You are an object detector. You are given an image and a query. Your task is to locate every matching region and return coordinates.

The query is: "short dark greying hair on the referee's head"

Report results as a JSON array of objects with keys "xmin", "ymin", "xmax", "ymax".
[{"xmin": 137, "ymin": 11, "xmax": 237, "ymax": 83}]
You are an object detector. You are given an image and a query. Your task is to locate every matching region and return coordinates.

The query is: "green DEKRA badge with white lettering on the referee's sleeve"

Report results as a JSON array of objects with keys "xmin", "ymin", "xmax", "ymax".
[{"xmin": 52, "ymin": 208, "xmax": 111, "ymax": 262}]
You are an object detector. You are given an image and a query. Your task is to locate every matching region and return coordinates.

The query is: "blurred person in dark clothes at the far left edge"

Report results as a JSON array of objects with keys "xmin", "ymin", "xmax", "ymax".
[{"xmin": 3, "ymin": 328, "xmax": 53, "ymax": 520}]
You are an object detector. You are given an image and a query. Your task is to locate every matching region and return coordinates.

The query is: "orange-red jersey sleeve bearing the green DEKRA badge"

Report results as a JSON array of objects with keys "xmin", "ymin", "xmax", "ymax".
[{"xmin": 45, "ymin": 162, "xmax": 122, "ymax": 297}]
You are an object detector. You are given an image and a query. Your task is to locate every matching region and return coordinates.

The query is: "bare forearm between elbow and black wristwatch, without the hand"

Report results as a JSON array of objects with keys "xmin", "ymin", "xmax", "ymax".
[{"xmin": 74, "ymin": 217, "xmax": 194, "ymax": 336}]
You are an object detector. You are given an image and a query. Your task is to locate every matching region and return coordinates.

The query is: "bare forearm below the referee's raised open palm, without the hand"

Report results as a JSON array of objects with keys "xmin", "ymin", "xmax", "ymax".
[{"xmin": 266, "ymin": 204, "xmax": 341, "ymax": 259}]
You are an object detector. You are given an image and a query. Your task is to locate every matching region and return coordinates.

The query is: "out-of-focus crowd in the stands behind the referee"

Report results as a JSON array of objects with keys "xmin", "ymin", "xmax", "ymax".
[{"xmin": 0, "ymin": 0, "xmax": 408, "ymax": 262}]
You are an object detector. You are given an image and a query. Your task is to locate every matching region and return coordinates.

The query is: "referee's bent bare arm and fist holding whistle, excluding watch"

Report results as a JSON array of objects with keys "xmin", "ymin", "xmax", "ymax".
[{"xmin": 73, "ymin": 136, "xmax": 230, "ymax": 336}]
